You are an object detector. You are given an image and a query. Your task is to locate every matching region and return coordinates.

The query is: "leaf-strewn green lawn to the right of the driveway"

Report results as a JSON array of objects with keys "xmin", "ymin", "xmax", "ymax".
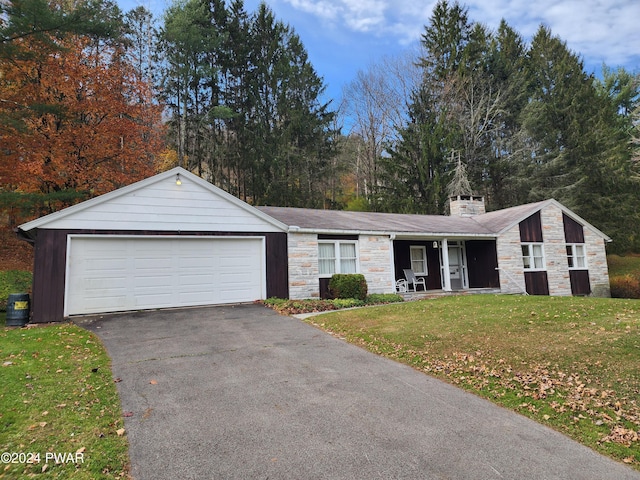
[{"xmin": 307, "ymin": 295, "xmax": 640, "ymax": 470}]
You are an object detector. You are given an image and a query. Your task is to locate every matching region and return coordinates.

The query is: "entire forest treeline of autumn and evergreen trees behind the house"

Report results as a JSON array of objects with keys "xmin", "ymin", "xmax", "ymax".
[{"xmin": 0, "ymin": 0, "xmax": 640, "ymax": 252}]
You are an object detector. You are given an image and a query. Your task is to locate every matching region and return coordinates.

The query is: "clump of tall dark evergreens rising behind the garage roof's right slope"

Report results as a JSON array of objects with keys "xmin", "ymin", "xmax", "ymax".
[{"xmin": 161, "ymin": 0, "xmax": 334, "ymax": 206}]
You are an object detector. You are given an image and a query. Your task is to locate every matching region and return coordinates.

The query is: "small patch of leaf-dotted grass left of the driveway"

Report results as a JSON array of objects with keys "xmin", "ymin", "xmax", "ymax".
[{"xmin": 0, "ymin": 323, "xmax": 129, "ymax": 480}]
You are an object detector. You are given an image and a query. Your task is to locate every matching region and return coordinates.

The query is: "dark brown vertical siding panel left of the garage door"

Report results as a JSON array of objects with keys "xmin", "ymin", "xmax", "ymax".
[{"xmin": 31, "ymin": 230, "xmax": 67, "ymax": 323}]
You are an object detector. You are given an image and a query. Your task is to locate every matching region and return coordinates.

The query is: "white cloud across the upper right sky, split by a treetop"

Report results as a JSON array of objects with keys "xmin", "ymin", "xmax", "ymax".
[{"xmin": 280, "ymin": 0, "xmax": 640, "ymax": 70}]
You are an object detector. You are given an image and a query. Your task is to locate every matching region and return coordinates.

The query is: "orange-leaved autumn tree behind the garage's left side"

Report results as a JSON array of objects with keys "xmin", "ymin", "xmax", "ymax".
[{"xmin": 0, "ymin": 0, "xmax": 164, "ymax": 219}]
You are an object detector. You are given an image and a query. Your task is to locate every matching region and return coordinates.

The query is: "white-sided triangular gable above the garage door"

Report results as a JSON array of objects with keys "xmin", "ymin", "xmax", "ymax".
[{"xmin": 18, "ymin": 167, "xmax": 287, "ymax": 236}]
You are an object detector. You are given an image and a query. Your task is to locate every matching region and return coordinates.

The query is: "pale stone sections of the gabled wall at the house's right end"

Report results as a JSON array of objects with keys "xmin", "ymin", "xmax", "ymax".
[{"xmin": 496, "ymin": 205, "xmax": 611, "ymax": 297}]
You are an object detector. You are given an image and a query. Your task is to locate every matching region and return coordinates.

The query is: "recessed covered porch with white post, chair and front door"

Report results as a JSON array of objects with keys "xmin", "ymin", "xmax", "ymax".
[{"xmin": 393, "ymin": 236, "xmax": 500, "ymax": 296}]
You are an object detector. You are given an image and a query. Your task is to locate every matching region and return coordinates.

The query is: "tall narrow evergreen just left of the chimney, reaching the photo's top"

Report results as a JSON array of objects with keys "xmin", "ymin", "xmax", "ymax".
[{"xmin": 376, "ymin": 0, "xmax": 471, "ymax": 214}]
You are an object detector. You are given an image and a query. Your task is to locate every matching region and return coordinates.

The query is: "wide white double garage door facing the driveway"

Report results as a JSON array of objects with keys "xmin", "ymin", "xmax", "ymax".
[{"xmin": 65, "ymin": 236, "xmax": 266, "ymax": 315}]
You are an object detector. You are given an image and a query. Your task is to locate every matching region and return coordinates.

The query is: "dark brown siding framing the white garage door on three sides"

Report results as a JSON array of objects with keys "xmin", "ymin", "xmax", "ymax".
[{"xmin": 31, "ymin": 229, "xmax": 289, "ymax": 323}]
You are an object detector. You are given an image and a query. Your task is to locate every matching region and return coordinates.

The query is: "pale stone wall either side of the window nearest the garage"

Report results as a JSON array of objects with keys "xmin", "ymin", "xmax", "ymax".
[{"xmin": 288, "ymin": 233, "xmax": 394, "ymax": 299}]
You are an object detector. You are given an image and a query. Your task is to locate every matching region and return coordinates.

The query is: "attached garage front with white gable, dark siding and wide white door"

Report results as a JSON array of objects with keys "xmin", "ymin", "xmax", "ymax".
[{"xmin": 18, "ymin": 168, "xmax": 288, "ymax": 322}]
